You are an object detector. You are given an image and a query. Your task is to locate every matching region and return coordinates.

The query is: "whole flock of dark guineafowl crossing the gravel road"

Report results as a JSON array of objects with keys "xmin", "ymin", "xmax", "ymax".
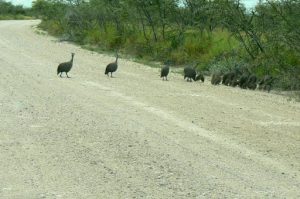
[{"xmin": 57, "ymin": 52, "xmax": 275, "ymax": 92}]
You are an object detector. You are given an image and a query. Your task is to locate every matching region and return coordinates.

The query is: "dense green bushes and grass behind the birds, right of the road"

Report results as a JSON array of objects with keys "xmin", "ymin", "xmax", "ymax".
[{"xmin": 5, "ymin": 0, "xmax": 300, "ymax": 90}]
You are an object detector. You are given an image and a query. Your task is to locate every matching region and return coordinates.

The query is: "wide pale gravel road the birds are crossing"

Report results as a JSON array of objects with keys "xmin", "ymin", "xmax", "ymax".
[{"xmin": 0, "ymin": 20, "xmax": 300, "ymax": 199}]
